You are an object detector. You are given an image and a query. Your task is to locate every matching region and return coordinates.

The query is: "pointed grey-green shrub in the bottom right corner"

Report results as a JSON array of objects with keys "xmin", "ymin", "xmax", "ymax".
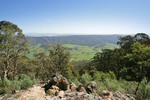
[{"xmin": 136, "ymin": 77, "xmax": 150, "ymax": 100}]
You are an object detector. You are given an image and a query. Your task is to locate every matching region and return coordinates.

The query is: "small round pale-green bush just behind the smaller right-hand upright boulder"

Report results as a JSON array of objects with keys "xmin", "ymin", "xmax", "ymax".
[{"xmin": 79, "ymin": 73, "xmax": 92, "ymax": 85}]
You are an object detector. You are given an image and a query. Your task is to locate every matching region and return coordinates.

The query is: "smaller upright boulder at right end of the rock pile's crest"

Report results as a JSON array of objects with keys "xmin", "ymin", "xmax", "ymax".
[{"xmin": 85, "ymin": 81, "xmax": 98, "ymax": 93}]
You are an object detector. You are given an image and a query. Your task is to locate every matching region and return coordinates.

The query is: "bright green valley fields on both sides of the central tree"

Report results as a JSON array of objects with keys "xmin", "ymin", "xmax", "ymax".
[{"xmin": 27, "ymin": 43, "xmax": 118, "ymax": 61}]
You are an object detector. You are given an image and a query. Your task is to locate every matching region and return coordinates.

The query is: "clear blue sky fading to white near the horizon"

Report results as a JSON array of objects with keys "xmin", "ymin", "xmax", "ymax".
[{"xmin": 0, "ymin": 0, "xmax": 150, "ymax": 34}]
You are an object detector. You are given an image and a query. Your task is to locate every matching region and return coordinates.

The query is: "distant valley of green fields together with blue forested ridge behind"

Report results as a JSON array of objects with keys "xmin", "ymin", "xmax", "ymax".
[{"xmin": 26, "ymin": 35, "xmax": 121, "ymax": 61}]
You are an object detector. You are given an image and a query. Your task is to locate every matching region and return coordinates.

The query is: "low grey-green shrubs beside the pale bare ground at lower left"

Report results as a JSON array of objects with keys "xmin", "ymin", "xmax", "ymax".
[{"xmin": 0, "ymin": 74, "xmax": 36, "ymax": 94}]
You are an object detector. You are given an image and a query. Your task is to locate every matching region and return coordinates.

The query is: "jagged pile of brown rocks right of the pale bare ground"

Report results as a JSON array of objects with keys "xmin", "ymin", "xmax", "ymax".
[{"xmin": 44, "ymin": 75, "xmax": 135, "ymax": 100}]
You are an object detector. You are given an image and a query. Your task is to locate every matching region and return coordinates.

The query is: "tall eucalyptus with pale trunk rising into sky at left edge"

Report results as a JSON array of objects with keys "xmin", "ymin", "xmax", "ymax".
[{"xmin": 0, "ymin": 21, "xmax": 27, "ymax": 78}]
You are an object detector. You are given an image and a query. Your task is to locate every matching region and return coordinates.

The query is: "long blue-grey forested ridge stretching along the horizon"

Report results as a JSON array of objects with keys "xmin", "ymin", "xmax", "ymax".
[{"xmin": 26, "ymin": 34, "xmax": 122, "ymax": 46}]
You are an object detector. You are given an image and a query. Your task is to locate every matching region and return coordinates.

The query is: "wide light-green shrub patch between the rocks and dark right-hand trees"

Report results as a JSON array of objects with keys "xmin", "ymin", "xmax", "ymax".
[{"xmin": 92, "ymin": 72, "xmax": 137, "ymax": 94}]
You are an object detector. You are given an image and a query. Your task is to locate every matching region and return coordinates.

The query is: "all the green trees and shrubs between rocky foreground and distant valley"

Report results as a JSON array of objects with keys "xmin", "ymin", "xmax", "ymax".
[{"xmin": 0, "ymin": 21, "xmax": 150, "ymax": 100}]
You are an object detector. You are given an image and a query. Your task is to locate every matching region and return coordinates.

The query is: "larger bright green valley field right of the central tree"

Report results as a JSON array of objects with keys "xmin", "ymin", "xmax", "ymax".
[{"xmin": 64, "ymin": 43, "xmax": 118, "ymax": 61}]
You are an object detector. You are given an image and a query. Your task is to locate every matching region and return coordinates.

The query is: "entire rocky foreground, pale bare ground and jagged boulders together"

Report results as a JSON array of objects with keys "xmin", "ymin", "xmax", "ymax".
[{"xmin": 0, "ymin": 75, "xmax": 135, "ymax": 100}]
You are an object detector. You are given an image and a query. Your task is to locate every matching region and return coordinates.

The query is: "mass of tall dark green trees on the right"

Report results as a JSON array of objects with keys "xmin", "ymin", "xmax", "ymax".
[{"xmin": 90, "ymin": 33, "xmax": 150, "ymax": 82}]
